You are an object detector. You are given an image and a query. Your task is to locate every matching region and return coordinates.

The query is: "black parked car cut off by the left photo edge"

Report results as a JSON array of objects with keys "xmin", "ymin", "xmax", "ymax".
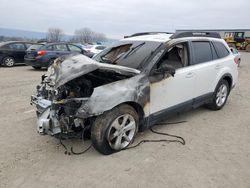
[{"xmin": 0, "ymin": 41, "xmax": 35, "ymax": 67}]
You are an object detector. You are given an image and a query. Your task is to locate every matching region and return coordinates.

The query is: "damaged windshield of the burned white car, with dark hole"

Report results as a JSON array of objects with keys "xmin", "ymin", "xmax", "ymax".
[{"xmin": 93, "ymin": 40, "xmax": 161, "ymax": 70}]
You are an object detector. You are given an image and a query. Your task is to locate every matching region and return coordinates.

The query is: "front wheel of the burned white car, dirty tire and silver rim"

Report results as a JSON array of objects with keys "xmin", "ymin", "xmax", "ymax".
[{"xmin": 91, "ymin": 104, "xmax": 139, "ymax": 155}]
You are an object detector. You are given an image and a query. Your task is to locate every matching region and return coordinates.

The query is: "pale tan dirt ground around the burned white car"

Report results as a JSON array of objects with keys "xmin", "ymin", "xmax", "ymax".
[{"xmin": 0, "ymin": 53, "xmax": 250, "ymax": 188}]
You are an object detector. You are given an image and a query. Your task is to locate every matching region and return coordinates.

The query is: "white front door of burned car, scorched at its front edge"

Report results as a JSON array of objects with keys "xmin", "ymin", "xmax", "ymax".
[{"xmin": 150, "ymin": 43, "xmax": 195, "ymax": 121}]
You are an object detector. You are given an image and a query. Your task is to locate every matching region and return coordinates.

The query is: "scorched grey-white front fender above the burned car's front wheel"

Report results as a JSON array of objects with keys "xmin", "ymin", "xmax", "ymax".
[{"xmin": 76, "ymin": 74, "xmax": 150, "ymax": 118}]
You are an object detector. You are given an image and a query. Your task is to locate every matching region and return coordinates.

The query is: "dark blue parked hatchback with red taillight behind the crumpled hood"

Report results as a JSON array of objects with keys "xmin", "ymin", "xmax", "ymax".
[{"xmin": 24, "ymin": 43, "xmax": 90, "ymax": 69}]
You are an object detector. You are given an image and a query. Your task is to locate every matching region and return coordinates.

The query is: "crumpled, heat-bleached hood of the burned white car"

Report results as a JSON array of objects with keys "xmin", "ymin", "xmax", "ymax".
[{"xmin": 47, "ymin": 55, "xmax": 140, "ymax": 88}]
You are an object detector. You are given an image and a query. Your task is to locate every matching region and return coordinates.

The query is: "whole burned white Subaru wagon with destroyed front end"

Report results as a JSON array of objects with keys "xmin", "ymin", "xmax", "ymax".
[{"xmin": 31, "ymin": 32, "xmax": 238, "ymax": 154}]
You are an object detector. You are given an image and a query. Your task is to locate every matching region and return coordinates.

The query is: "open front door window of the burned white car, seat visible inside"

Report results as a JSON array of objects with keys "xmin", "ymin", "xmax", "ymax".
[{"xmin": 156, "ymin": 43, "xmax": 189, "ymax": 69}]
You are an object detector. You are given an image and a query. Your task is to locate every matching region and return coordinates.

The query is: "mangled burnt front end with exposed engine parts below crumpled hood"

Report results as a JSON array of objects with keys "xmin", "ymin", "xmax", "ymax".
[{"xmin": 31, "ymin": 74, "xmax": 92, "ymax": 135}]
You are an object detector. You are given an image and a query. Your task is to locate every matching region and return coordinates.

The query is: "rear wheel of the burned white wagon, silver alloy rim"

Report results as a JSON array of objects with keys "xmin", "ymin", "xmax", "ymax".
[{"xmin": 207, "ymin": 79, "xmax": 230, "ymax": 110}]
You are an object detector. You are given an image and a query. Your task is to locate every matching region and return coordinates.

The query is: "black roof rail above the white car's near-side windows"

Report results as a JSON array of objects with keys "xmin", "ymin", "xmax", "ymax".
[{"xmin": 170, "ymin": 31, "xmax": 221, "ymax": 39}]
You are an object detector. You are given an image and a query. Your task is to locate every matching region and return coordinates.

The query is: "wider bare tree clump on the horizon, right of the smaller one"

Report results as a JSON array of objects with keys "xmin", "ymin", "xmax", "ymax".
[{"xmin": 71, "ymin": 27, "xmax": 106, "ymax": 44}]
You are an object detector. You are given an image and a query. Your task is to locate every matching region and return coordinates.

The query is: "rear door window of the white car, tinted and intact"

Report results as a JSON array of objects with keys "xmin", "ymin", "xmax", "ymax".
[{"xmin": 192, "ymin": 41, "xmax": 213, "ymax": 64}]
